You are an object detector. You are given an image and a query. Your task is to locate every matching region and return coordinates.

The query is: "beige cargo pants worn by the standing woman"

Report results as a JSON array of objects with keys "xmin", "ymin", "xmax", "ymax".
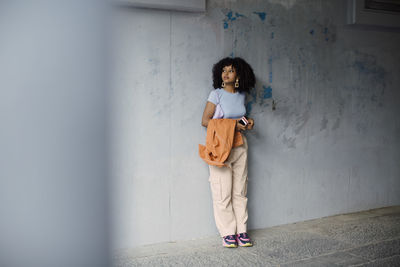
[{"xmin": 209, "ymin": 135, "xmax": 248, "ymax": 236}]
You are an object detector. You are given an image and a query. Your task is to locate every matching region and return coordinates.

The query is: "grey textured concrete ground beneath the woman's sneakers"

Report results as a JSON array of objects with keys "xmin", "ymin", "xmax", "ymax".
[{"xmin": 114, "ymin": 206, "xmax": 400, "ymax": 267}]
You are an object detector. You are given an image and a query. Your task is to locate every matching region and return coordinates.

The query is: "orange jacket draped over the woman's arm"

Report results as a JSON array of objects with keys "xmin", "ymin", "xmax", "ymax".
[{"xmin": 199, "ymin": 119, "xmax": 243, "ymax": 167}]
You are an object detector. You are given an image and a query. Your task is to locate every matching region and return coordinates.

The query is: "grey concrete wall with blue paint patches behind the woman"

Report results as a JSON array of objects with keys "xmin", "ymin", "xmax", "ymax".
[{"xmin": 111, "ymin": 0, "xmax": 400, "ymax": 251}]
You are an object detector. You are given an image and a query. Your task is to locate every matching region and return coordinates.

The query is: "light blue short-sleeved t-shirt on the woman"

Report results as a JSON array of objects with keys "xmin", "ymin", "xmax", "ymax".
[{"xmin": 207, "ymin": 88, "xmax": 246, "ymax": 119}]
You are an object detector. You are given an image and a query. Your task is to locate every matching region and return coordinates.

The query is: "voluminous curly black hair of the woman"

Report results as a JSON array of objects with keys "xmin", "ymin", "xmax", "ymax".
[{"xmin": 212, "ymin": 57, "xmax": 256, "ymax": 93}]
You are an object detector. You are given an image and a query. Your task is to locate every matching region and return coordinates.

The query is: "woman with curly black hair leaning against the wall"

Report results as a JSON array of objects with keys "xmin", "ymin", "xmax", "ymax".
[{"xmin": 202, "ymin": 58, "xmax": 255, "ymax": 247}]
